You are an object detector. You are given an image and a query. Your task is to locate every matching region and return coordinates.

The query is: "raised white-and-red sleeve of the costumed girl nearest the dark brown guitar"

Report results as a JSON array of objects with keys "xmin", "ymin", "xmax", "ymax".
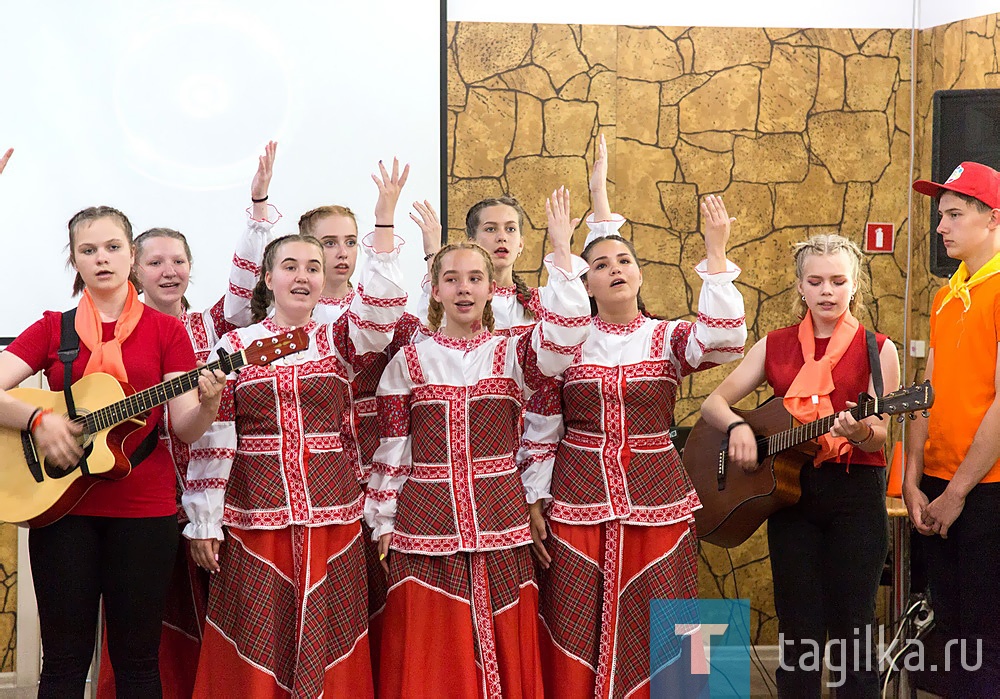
[{"xmin": 665, "ymin": 260, "xmax": 747, "ymax": 376}]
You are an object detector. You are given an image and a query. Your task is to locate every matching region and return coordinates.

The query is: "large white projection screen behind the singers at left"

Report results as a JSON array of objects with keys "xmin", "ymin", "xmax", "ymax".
[{"xmin": 0, "ymin": 0, "xmax": 442, "ymax": 337}]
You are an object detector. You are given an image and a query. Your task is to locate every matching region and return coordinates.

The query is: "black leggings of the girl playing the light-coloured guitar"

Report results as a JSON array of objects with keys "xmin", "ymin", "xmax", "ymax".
[{"xmin": 28, "ymin": 515, "xmax": 178, "ymax": 699}]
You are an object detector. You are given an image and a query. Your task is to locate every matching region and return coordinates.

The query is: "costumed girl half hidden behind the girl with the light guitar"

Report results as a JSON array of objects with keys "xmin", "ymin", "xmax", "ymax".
[{"xmin": 97, "ymin": 141, "xmax": 277, "ymax": 698}]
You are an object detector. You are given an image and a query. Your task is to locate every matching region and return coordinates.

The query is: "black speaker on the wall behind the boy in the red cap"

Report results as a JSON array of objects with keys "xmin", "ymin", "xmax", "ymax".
[{"xmin": 930, "ymin": 90, "xmax": 1000, "ymax": 277}]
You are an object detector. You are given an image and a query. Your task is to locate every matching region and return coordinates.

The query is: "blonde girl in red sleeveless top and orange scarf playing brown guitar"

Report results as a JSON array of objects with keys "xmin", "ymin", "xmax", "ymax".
[{"xmin": 702, "ymin": 235, "xmax": 899, "ymax": 697}]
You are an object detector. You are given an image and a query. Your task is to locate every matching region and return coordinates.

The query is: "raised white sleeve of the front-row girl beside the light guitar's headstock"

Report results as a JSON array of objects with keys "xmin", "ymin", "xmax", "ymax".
[{"xmin": 331, "ymin": 234, "xmax": 406, "ymax": 369}]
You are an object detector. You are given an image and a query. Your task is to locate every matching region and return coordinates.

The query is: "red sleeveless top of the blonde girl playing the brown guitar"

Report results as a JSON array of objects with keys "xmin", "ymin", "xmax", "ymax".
[{"xmin": 764, "ymin": 325, "xmax": 887, "ymax": 466}]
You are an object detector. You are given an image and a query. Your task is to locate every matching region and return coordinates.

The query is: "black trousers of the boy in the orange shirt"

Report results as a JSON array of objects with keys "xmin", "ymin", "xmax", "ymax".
[{"xmin": 920, "ymin": 476, "xmax": 1000, "ymax": 699}]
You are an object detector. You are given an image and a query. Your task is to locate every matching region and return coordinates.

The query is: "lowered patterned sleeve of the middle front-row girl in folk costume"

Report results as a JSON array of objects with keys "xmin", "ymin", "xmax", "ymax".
[{"xmin": 365, "ymin": 348, "xmax": 413, "ymax": 541}]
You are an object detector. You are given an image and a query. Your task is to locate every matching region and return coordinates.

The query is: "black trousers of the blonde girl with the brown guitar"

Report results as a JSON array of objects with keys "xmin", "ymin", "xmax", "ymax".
[{"xmin": 767, "ymin": 463, "xmax": 889, "ymax": 699}]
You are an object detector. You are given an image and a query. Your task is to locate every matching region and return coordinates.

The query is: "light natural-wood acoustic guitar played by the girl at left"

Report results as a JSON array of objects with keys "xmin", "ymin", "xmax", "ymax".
[{"xmin": 0, "ymin": 328, "xmax": 309, "ymax": 527}]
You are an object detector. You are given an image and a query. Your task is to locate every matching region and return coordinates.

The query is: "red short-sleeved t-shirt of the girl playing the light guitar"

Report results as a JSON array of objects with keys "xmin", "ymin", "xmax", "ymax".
[{"xmin": 7, "ymin": 306, "xmax": 195, "ymax": 517}]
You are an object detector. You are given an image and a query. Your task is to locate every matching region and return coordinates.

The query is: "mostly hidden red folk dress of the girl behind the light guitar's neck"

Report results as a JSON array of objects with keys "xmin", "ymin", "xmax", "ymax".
[{"xmin": 97, "ymin": 207, "xmax": 280, "ymax": 699}]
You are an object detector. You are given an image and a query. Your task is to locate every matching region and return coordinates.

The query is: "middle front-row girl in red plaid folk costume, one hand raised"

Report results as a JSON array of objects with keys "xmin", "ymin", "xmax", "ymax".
[{"xmin": 365, "ymin": 191, "xmax": 588, "ymax": 697}]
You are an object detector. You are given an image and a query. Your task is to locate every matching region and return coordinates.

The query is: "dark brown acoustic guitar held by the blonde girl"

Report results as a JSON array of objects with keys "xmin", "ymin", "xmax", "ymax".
[{"xmin": 683, "ymin": 381, "xmax": 934, "ymax": 548}]
